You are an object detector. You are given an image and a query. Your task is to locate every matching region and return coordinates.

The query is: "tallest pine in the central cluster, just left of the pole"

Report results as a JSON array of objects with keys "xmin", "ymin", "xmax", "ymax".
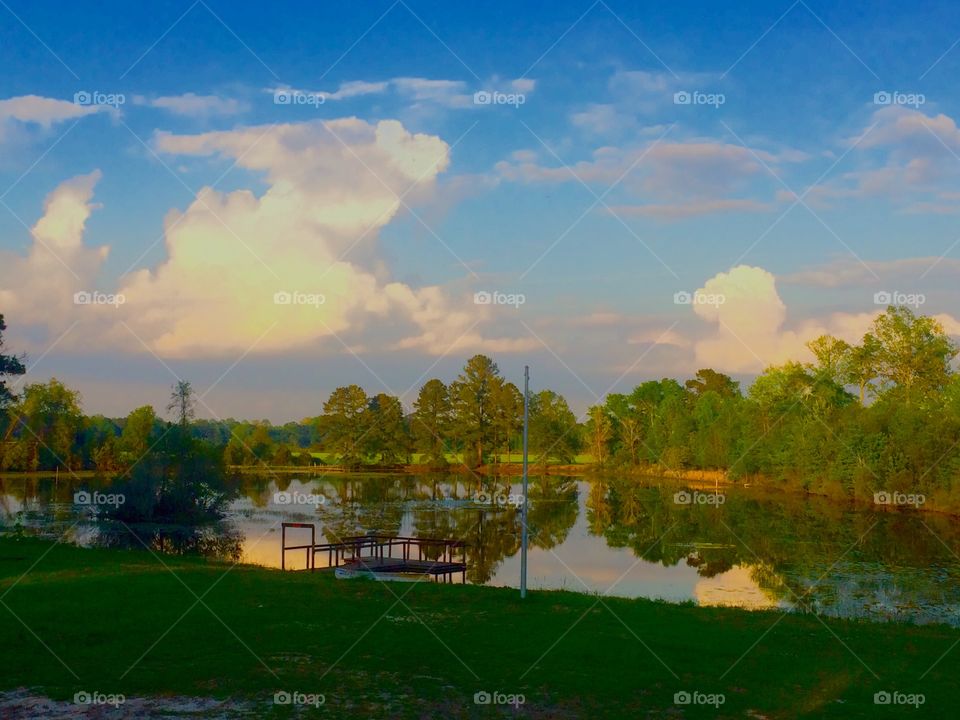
[{"xmin": 450, "ymin": 355, "xmax": 503, "ymax": 466}]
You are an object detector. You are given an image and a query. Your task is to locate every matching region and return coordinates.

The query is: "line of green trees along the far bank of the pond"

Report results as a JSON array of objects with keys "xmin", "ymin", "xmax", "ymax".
[{"xmin": 0, "ymin": 306, "xmax": 960, "ymax": 510}]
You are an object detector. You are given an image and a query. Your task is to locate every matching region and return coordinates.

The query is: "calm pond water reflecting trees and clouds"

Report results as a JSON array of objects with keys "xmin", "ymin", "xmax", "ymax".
[{"xmin": 0, "ymin": 475, "xmax": 960, "ymax": 626}]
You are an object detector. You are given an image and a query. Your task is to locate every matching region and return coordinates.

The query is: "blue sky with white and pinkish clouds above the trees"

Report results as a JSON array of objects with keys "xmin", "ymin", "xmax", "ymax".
[{"xmin": 0, "ymin": 0, "xmax": 960, "ymax": 422}]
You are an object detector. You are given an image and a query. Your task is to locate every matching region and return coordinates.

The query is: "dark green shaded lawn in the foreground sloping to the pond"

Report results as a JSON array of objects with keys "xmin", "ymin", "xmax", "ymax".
[{"xmin": 0, "ymin": 538, "xmax": 960, "ymax": 718}]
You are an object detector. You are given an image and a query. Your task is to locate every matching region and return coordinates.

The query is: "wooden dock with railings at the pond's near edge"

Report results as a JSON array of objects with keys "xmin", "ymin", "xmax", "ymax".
[{"xmin": 280, "ymin": 523, "xmax": 467, "ymax": 583}]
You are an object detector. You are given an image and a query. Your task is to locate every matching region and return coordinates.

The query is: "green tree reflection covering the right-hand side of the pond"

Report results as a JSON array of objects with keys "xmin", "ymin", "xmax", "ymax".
[{"xmin": 586, "ymin": 478, "xmax": 960, "ymax": 624}]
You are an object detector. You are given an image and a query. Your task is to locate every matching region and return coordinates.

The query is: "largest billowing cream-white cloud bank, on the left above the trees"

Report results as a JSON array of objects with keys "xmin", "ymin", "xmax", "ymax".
[{"xmin": 0, "ymin": 118, "xmax": 533, "ymax": 358}]
